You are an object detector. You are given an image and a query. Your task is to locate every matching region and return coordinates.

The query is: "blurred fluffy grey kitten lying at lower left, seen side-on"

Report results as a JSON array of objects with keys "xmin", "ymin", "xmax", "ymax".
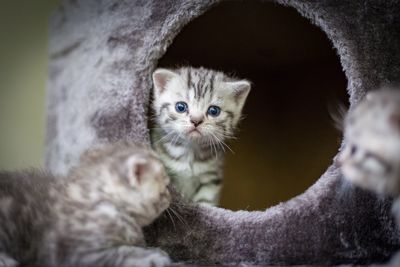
[{"xmin": 0, "ymin": 142, "xmax": 170, "ymax": 267}]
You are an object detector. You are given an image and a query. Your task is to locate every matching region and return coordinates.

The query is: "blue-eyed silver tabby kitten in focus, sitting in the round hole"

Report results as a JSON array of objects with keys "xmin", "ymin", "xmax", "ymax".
[{"xmin": 151, "ymin": 67, "xmax": 250, "ymax": 205}]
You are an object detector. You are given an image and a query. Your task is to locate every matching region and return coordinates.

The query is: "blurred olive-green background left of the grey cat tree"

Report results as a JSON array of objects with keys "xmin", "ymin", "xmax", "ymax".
[{"xmin": 0, "ymin": 0, "xmax": 59, "ymax": 169}]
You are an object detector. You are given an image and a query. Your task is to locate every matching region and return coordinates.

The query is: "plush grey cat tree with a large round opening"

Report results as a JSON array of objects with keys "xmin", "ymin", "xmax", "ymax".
[{"xmin": 46, "ymin": 0, "xmax": 400, "ymax": 265}]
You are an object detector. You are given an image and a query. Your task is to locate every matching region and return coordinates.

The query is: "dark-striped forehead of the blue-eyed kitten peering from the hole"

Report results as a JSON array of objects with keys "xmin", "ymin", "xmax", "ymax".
[{"xmin": 180, "ymin": 68, "xmax": 220, "ymax": 100}]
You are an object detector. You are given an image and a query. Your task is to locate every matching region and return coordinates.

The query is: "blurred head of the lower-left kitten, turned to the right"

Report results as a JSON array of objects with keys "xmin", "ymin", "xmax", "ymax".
[{"xmin": 79, "ymin": 143, "xmax": 170, "ymax": 223}]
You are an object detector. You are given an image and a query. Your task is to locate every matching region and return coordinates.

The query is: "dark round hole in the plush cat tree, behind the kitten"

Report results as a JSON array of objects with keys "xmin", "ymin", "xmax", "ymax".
[{"xmin": 155, "ymin": 1, "xmax": 348, "ymax": 210}]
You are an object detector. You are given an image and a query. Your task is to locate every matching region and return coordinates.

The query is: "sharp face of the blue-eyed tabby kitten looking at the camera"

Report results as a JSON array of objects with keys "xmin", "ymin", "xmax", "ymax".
[{"xmin": 153, "ymin": 68, "xmax": 250, "ymax": 147}]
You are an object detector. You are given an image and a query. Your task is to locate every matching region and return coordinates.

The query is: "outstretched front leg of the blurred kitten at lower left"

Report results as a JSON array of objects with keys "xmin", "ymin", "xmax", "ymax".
[{"xmin": 64, "ymin": 246, "xmax": 171, "ymax": 267}]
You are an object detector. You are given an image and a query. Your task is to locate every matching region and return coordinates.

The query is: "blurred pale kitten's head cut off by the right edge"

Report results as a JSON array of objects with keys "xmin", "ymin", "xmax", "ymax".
[{"xmin": 339, "ymin": 90, "xmax": 400, "ymax": 196}]
